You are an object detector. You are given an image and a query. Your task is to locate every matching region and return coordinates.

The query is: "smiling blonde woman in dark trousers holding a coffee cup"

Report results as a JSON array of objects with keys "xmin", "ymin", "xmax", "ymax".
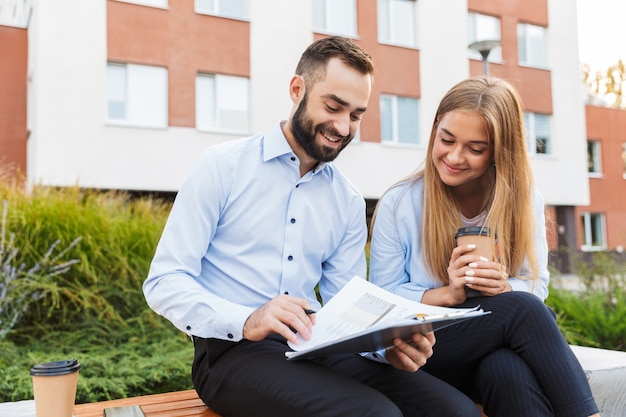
[{"xmin": 370, "ymin": 77, "xmax": 598, "ymax": 417}]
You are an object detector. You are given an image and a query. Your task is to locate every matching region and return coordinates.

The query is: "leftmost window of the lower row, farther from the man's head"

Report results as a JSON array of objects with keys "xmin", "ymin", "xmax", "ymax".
[{"xmin": 107, "ymin": 63, "xmax": 167, "ymax": 127}]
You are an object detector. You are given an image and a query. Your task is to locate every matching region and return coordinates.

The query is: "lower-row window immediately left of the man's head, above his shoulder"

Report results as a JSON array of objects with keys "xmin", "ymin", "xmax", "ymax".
[{"xmin": 196, "ymin": 74, "xmax": 250, "ymax": 132}]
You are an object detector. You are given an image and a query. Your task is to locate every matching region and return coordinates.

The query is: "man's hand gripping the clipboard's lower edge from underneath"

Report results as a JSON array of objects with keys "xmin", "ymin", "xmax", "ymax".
[{"xmin": 385, "ymin": 332, "xmax": 436, "ymax": 372}]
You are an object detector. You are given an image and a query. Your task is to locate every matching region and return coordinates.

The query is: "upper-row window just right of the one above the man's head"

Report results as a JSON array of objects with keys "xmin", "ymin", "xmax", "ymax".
[{"xmin": 378, "ymin": 0, "xmax": 417, "ymax": 48}]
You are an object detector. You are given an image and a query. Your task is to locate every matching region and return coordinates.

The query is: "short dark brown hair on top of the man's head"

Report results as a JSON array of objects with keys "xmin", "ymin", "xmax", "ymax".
[{"xmin": 296, "ymin": 36, "xmax": 374, "ymax": 86}]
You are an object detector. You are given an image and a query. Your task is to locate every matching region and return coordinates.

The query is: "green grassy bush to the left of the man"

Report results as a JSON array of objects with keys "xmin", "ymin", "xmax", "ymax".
[{"xmin": 0, "ymin": 184, "xmax": 193, "ymax": 403}]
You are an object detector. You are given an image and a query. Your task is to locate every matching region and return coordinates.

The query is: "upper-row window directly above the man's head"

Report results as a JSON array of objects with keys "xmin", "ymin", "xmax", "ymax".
[{"xmin": 313, "ymin": 0, "xmax": 356, "ymax": 37}]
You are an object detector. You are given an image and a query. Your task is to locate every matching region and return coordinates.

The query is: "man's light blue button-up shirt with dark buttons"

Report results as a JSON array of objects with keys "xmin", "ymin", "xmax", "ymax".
[{"xmin": 143, "ymin": 124, "xmax": 367, "ymax": 341}]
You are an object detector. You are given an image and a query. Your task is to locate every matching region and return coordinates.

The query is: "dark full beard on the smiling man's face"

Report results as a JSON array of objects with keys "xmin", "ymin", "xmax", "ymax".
[{"xmin": 290, "ymin": 93, "xmax": 354, "ymax": 162}]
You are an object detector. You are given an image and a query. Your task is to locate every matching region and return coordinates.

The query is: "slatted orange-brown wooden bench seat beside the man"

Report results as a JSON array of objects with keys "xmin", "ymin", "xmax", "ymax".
[{"xmin": 74, "ymin": 390, "xmax": 221, "ymax": 417}]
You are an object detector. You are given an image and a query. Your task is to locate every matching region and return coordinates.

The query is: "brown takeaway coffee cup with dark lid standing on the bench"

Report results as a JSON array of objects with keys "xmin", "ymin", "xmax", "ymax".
[{"xmin": 30, "ymin": 359, "xmax": 80, "ymax": 417}]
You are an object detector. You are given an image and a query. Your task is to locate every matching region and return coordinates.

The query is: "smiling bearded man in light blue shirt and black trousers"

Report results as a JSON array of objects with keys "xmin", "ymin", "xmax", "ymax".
[{"xmin": 143, "ymin": 37, "xmax": 478, "ymax": 417}]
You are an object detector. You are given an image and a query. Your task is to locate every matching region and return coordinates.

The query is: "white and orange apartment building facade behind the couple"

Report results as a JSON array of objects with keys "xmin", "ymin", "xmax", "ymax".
[{"xmin": 0, "ymin": 0, "xmax": 600, "ymax": 266}]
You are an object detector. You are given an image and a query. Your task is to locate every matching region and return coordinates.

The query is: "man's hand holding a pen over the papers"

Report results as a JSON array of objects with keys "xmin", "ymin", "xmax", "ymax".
[{"xmin": 243, "ymin": 295, "xmax": 315, "ymax": 343}]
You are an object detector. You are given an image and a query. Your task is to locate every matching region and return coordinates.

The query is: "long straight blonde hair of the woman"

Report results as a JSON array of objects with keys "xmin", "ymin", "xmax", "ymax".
[{"xmin": 411, "ymin": 76, "xmax": 544, "ymax": 284}]
